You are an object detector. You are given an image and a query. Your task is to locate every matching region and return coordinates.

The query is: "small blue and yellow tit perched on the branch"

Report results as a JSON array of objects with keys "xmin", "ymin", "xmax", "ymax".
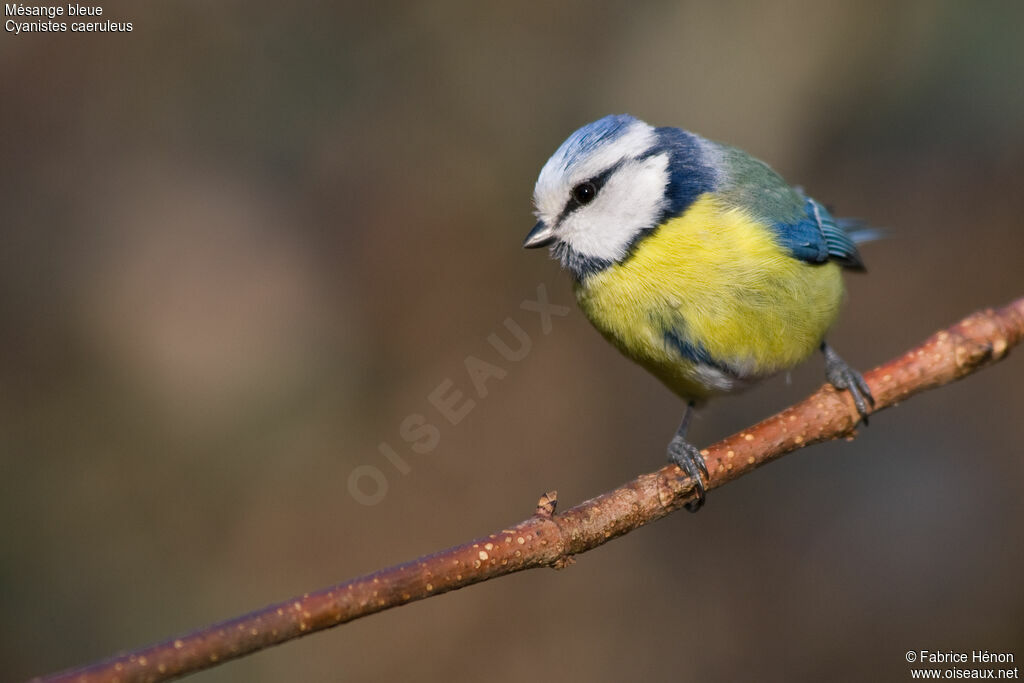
[{"xmin": 523, "ymin": 114, "xmax": 881, "ymax": 511}]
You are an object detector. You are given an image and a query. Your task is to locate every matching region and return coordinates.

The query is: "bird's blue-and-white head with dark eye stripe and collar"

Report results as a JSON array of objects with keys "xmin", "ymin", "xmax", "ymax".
[{"xmin": 523, "ymin": 115, "xmax": 715, "ymax": 279}]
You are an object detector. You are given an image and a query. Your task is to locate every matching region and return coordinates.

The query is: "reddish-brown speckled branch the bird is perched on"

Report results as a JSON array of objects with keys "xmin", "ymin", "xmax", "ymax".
[{"xmin": 37, "ymin": 298, "xmax": 1024, "ymax": 682}]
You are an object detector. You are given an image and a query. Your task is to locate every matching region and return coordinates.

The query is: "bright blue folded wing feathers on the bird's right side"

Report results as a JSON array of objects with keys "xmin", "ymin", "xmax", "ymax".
[{"xmin": 772, "ymin": 198, "xmax": 865, "ymax": 270}]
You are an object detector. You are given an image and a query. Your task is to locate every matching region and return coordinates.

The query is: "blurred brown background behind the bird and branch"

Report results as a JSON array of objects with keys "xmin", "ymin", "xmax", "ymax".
[{"xmin": 0, "ymin": 0, "xmax": 1024, "ymax": 681}]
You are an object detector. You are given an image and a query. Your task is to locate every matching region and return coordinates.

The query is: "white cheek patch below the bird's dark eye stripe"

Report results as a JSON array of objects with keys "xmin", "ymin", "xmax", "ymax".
[{"xmin": 556, "ymin": 154, "xmax": 669, "ymax": 261}]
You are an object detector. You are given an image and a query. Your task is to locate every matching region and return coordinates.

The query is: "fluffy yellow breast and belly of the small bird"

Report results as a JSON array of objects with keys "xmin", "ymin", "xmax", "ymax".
[{"xmin": 577, "ymin": 195, "xmax": 843, "ymax": 398}]
